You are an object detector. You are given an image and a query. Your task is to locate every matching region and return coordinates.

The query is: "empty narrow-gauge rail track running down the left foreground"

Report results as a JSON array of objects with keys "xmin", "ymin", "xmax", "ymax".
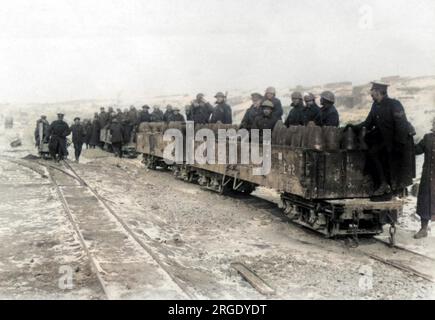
[{"xmin": 5, "ymin": 158, "xmax": 197, "ymax": 300}]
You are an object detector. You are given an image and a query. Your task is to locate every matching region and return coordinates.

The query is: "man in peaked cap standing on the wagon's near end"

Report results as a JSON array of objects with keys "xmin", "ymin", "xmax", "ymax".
[{"xmin": 346, "ymin": 82, "xmax": 415, "ymax": 196}]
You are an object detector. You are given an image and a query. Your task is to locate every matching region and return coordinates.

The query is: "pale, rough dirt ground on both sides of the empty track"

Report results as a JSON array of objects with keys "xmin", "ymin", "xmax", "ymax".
[{"xmin": 0, "ymin": 111, "xmax": 435, "ymax": 299}]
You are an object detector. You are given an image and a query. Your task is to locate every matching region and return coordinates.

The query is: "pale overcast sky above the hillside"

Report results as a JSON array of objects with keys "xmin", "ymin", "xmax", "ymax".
[{"xmin": 0, "ymin": 0, "xmax": 435, "ymax": 102}]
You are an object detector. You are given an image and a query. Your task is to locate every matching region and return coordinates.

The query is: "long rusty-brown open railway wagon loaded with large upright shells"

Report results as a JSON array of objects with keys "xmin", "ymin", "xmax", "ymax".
[{"xmin": 137, "ymin": 122, "xmax": 403, "ymax": 243}]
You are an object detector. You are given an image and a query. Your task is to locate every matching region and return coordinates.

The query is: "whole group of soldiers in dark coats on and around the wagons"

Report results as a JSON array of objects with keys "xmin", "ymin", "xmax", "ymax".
[{"xmin": 35, "ymin": 83, "xmax": 435, "ymax": 238}]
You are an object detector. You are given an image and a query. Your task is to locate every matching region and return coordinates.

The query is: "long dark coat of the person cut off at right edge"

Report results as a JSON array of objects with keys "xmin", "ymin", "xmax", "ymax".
[{"xmin": 415, "ymin": 133, "xmax": 435, "ymax": 220}]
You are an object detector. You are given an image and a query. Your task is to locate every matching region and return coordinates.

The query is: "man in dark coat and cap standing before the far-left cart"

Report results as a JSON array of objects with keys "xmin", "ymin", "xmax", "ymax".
[{"xmin": 48, "ymin": 113, "xmax": 71, "ymax": 162}]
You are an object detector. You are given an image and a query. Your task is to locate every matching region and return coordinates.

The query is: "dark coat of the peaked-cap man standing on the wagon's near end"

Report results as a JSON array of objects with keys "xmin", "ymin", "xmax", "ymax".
[{"xmin": 355, "ymin": 96, "xmax": 415, "ymax": 190}]
